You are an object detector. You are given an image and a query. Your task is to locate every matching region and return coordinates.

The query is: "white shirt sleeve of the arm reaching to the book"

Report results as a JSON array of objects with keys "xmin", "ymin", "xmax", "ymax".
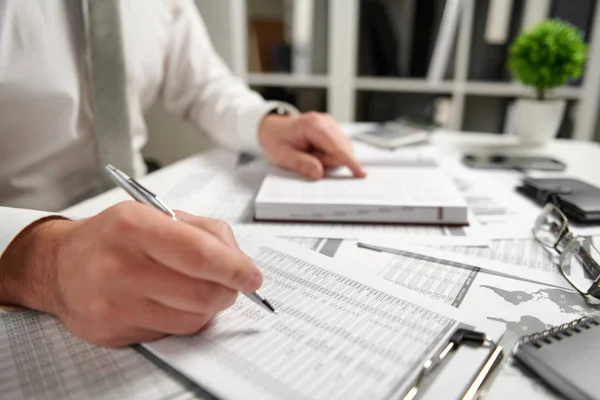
[{"xmin": 162, "ymin": 0, "xmax": 298, "ymax": 153}]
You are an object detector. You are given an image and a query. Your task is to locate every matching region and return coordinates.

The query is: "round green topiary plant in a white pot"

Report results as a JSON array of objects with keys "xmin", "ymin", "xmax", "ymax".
[{"xmin": 508, "ymin": 20, "xmax": 588, "ymax": 145}]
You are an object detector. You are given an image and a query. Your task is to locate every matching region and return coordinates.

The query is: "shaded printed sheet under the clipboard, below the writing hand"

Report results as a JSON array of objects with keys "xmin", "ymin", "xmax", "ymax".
[{"xmin": 0, "ymin": 311, "xmax": 197, "ymax": 400}]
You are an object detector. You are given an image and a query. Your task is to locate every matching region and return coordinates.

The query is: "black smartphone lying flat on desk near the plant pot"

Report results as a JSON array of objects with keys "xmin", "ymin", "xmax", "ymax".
[{"xmin": 463, "ymin": 154, "xmax": 566, "ymax": 171}]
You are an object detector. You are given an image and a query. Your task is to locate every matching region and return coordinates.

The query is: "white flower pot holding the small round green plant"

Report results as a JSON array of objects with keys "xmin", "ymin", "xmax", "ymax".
[{"xmin": 514, "ymin": 99, "xmax": 567, "ymax": 145}]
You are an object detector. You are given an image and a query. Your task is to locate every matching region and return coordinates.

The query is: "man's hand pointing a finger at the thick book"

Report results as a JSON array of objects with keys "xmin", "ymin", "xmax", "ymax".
[{"xmin": 258, "ymin": 112, "xmax": 366, "ymax": 179}]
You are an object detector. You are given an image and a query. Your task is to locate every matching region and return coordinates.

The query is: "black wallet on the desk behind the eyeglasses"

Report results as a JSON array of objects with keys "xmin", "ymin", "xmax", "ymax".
[{"xmin": 517, "ymin": 178, "xmax": 600, "ymax": 223}]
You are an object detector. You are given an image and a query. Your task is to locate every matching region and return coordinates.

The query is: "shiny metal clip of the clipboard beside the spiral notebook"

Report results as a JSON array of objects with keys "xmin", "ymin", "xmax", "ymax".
[{"xmin": 402, "ymin": 329, "xmax": 504, "ymax": 400}]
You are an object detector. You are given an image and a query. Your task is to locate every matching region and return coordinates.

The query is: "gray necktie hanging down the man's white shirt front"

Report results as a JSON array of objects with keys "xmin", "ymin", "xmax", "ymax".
[{"xmin": 87, "ymin": 0, "xmax": 134, "ymax": 188}]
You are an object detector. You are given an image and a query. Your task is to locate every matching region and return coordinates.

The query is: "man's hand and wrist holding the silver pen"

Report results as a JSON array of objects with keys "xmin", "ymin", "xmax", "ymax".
[{"xmin": 0, "ymin": 202, "xmax": 262, "ymax": 347}]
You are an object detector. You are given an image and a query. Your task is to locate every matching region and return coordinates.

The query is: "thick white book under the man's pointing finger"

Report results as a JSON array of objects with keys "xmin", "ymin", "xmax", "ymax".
[{"xmin": 254, "ymin": 166, "xmax": 467, "ymax": 225}]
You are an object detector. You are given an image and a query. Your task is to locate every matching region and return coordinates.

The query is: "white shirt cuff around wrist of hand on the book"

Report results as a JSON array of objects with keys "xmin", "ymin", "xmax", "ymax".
[{"xmin": 238, "ymin": 101, "xmax": 300, "ymax": 154}]
